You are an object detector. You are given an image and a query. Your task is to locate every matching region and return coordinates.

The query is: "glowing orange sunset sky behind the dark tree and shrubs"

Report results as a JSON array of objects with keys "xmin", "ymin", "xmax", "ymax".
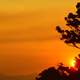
[{"xmin": 0, "ymin": 0, "xmax": 79, "ymax": 75}]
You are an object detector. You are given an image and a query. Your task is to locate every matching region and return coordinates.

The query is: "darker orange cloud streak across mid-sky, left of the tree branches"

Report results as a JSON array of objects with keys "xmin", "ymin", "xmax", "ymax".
[{"xmin": 0, "ymin": 27, "xmax": 56, "ymax": 43}]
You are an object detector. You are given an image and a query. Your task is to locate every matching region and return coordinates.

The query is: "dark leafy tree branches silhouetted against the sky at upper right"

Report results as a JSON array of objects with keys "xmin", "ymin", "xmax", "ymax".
[{"xmin": 56, "ymin": 3, "xmax": 80, "ymax": 48}]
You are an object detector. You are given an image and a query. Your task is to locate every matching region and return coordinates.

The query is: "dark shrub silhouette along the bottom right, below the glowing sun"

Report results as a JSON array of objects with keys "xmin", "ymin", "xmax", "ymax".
[{"xmin": 36, "ymin": 54, "xmax": 80, "ymax": 80}]
